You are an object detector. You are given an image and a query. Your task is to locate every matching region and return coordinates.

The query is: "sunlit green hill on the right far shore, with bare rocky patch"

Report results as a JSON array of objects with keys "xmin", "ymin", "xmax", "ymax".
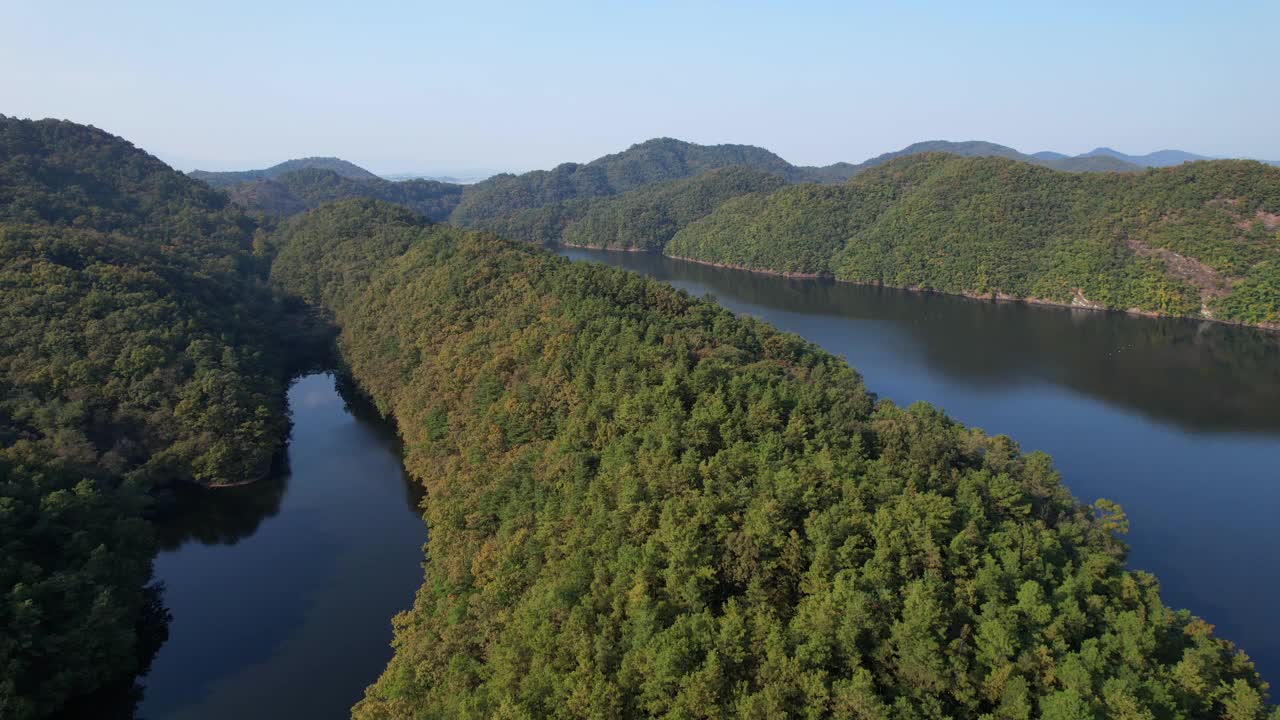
[{"xmin": 666, "ymin": 154, "xmax": 1280, "ymax": 324}]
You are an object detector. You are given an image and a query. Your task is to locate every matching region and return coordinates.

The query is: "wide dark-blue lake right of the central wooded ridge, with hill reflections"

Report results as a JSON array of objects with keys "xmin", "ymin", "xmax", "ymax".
[{"xmin": 562, "ymin": 249, "xmax": 1280, "ymax": 687}]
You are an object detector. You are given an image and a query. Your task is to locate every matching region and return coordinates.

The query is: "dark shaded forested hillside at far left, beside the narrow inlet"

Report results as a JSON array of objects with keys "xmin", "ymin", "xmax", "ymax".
[{"xmin": 0, "ymin": 117, "xmax": 300, "ymax": 720}]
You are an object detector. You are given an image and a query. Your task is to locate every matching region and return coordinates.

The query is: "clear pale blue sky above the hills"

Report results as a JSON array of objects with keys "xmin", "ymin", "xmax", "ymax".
[{"xmin": 0, "ymin": 0, "xmax": 1280, "ymax": 173}]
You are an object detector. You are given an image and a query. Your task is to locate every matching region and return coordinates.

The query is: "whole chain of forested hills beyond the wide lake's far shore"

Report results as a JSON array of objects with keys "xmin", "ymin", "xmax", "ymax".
[{"xmin": 202, "ymin": 138, "xmax": 1280, "ymax": 325}]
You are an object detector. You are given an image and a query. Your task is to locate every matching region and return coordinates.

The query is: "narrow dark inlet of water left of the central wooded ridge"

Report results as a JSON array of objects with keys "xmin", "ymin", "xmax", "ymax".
[{"xmin": 138, "ymin": 374, "xmax": 426, "ymax": 720}]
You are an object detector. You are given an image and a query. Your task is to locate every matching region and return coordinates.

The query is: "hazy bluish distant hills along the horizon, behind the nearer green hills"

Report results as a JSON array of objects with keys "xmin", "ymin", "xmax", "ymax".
[{"xmin": 188, "ymin": 137, "xmax": 1280, "ymax": 224}]
